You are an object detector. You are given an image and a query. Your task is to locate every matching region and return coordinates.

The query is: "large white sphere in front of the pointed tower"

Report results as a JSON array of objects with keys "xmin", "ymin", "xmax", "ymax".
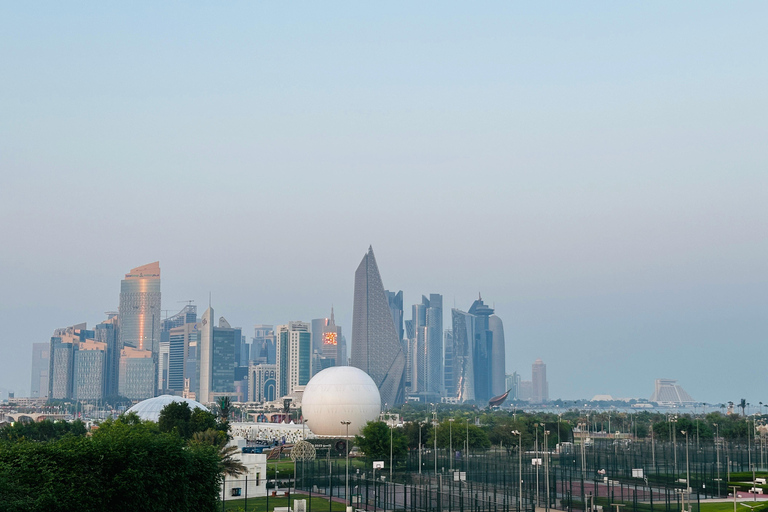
[{"xmin": 301, "ymin": 366, "xmax": 381, "ymax": 437}]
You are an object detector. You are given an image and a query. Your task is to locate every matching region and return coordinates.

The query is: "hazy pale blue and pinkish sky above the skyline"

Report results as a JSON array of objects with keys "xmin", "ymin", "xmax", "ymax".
[{"xmin": 0, "ymin": 2, "xmax": 768, "ymax": 403}]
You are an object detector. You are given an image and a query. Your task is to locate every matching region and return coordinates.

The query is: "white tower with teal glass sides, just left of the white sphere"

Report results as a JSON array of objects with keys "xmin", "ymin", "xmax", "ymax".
[{"xmin": 275, "ymin": 322, "xmax": 312, "ymax": 397}]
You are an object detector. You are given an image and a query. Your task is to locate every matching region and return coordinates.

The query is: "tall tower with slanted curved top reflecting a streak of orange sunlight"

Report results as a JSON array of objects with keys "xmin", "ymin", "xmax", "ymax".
[{"xmin": 118, "ymin": 261, "xmax": 162, "ymax": 399}]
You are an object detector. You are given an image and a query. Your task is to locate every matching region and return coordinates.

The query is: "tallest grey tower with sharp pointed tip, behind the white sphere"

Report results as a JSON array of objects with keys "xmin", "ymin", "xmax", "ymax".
[{"xmin": 352, "ymin": 247, "xmax": 405, "ymax": 405}]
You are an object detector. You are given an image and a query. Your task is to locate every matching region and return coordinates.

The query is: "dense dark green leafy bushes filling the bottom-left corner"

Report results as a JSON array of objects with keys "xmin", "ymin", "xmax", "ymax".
[{"xmin": 0, "ymin": 418, "xmax": 221, "ymax": 512}]
